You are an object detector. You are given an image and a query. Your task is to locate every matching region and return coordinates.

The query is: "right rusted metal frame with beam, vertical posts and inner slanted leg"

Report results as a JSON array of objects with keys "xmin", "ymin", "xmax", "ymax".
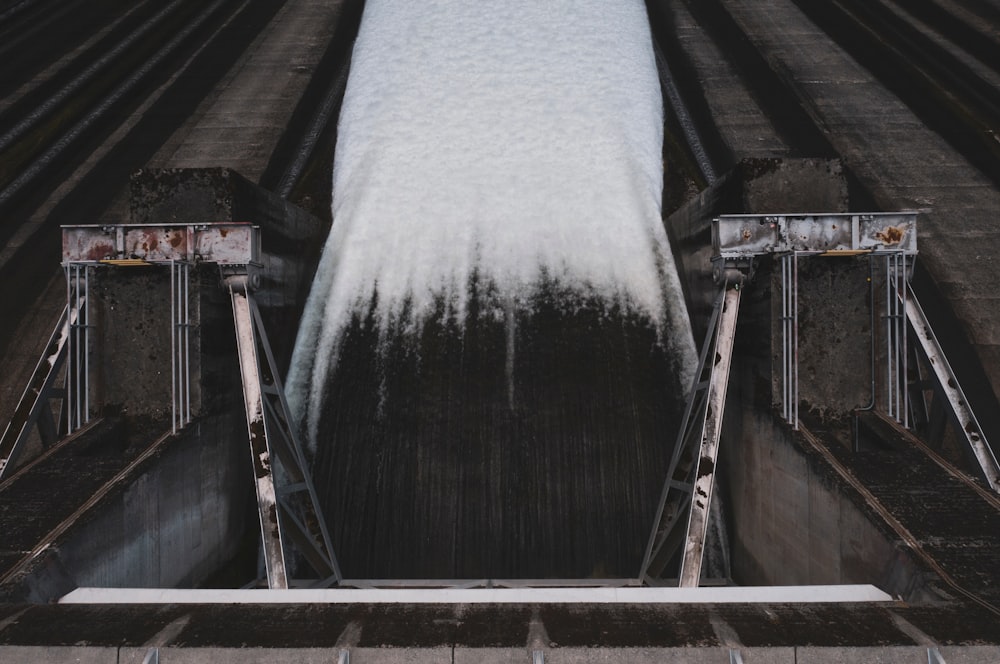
[{"xmin": 639, "ymin": 212, "xmax": 932, "ymax": 588}]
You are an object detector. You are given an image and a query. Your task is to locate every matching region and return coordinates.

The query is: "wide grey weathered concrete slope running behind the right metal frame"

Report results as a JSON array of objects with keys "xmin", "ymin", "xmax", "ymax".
[{"xmin": 721, "ymin": 0, "xmax": 1000, "ymax": 440}]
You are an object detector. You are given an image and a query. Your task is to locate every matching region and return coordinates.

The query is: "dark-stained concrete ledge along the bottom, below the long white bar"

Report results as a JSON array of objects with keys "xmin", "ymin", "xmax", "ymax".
[{"xmin": 0, "ymin": 602, "xmax": 1000, "ymax": 648}]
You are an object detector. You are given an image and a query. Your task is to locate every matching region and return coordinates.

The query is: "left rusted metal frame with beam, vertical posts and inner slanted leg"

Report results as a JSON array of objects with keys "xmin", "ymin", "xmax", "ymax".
[{"xmin": 57, "ymin": 223, "xmax": 341, "ymax": 588}]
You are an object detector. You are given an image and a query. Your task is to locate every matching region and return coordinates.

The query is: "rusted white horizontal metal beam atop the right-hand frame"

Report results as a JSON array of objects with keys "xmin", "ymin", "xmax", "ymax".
[{"xmin": 712, "ymin": 212, "xmax": 917, "ymax": 259}]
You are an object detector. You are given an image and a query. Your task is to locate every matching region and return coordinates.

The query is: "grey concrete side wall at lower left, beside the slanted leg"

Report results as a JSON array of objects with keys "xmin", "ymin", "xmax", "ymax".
[{"xmin": 12, "ymin": 411, "xmax": 250, "ymax": 602}]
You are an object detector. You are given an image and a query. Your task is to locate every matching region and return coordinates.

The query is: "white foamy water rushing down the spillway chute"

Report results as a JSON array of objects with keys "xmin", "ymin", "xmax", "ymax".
[{"xmin": 288, "ymin": 0, "xmax": 695, "ymax": 448}]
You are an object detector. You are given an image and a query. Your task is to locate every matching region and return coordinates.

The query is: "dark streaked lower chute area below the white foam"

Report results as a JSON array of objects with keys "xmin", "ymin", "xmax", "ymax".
[{"xmin": 314, "ymin": 292, "xmax": 683, "ymax": 578}]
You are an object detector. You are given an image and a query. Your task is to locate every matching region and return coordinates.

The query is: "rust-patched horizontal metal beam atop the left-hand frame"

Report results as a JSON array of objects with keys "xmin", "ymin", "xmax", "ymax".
[{"xmin": 62, "ymin": 222, "xmax": 260, "ymax": 265}]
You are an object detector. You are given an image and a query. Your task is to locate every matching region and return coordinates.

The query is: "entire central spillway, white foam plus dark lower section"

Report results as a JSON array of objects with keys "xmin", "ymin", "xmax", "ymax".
[{"xmin": 289, "ymin": 0, "xmax": 694, "ymax": 578}]
